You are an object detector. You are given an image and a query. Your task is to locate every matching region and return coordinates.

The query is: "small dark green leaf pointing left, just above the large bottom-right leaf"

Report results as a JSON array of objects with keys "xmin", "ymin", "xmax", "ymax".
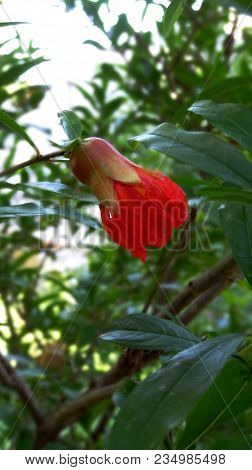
[{"xmin": 100, "ymin": 314, "xmax": 199, "ymax": 351}]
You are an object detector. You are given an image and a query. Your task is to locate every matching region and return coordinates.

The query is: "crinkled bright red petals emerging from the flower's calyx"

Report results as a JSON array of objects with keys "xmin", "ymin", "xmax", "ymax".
[{"xmin": 100, "ymin": 167, "xmax": 187, "ymax": 261}]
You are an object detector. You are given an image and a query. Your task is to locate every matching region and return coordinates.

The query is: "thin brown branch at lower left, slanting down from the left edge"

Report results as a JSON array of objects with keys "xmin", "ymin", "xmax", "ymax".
[{"xmin": 0, "ymin": 353, "xmax": 45, "ymax": 426}]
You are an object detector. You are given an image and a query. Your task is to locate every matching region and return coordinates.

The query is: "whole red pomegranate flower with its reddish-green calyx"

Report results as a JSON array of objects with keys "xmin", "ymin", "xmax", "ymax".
[{"xmin": 70, "ymin": 137, "xmax": 187, "ymax": 261}]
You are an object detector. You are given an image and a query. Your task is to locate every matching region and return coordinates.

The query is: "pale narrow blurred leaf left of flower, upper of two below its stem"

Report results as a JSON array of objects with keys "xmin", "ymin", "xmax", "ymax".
[{"xmin": 0, "ymin": 181, "xmax": 98, "ymax": 204}]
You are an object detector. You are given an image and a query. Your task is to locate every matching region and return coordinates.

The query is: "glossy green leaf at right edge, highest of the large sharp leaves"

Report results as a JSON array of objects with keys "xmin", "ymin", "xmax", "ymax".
[{"xmin": 189, "ymin": 100, "xmax": 252, "ymax": 152}]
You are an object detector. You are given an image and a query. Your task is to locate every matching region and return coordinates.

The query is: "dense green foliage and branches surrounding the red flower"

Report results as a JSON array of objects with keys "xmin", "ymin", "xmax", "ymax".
[{"xmin": 0, "ymin": 0, "xmax": 252, "ymax": 449}]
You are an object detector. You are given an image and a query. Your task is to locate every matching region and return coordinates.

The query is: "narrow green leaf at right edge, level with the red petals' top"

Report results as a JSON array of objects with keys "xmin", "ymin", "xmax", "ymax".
[{"xmin": 198, "ymin": 185, "xmax": 252, "ymax": 205}]
